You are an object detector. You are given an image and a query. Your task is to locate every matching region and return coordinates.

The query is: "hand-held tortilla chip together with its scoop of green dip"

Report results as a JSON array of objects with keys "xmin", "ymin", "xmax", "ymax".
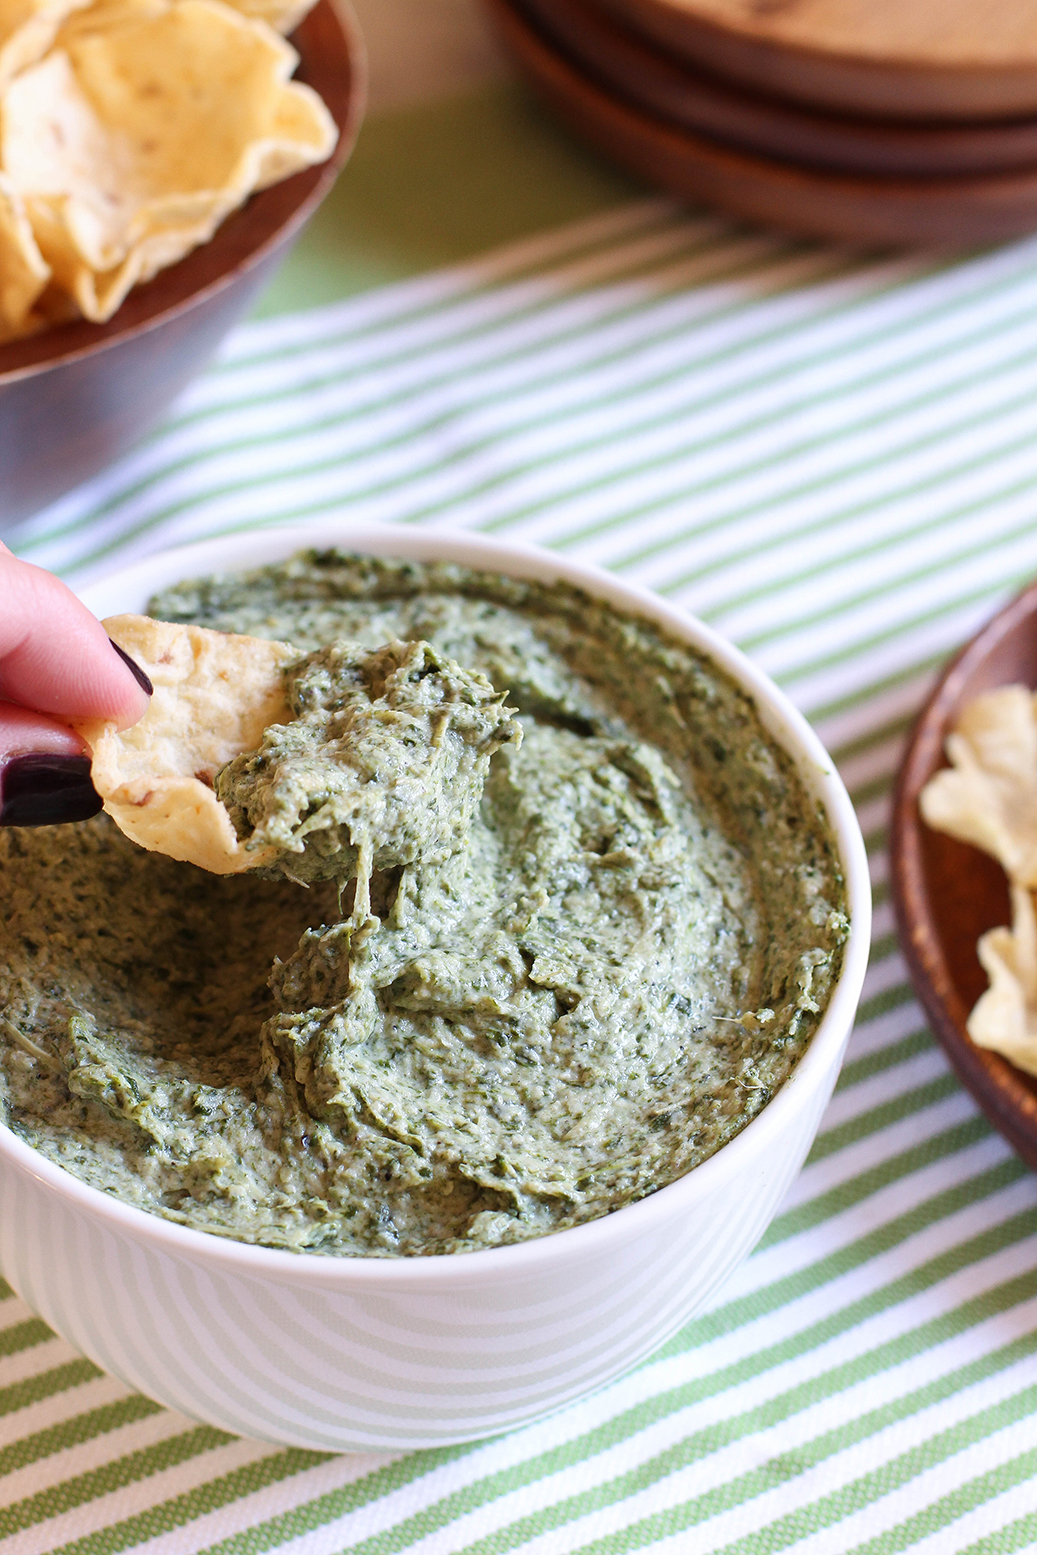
[{"xmin": 79, "ymin": 616, "xmax": 521, "ymax": 901}]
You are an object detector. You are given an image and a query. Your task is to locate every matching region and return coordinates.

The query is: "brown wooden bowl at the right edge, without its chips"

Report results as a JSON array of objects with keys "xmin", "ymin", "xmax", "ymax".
[{"xmin": 889, "ymin": 583, "xmax": 1037, "ymax": 1168}]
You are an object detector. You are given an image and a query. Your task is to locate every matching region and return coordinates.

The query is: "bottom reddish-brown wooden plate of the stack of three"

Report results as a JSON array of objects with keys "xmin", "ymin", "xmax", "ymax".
[{"xmin": 487, "ymin": 0, "xmax": 1037, "ymax": 247}]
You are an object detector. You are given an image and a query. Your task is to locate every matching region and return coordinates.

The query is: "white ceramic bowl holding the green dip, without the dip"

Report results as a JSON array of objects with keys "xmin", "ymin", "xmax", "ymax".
[{"xmin": 0, "ymin": 521, "xmax": 871, "ymax": 1451}]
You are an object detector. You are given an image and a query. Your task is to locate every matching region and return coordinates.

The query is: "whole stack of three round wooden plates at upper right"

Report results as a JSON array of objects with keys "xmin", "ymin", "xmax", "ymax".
[{"xmin": 487, "ymin": 0, "xmax": 1037, "ymax": 246}]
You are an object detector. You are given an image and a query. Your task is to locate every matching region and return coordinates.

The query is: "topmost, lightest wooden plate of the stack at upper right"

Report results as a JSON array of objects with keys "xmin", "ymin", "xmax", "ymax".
[{"xmin": 602, "ymin": 0, "xmax": 1037, "ymax": 118}]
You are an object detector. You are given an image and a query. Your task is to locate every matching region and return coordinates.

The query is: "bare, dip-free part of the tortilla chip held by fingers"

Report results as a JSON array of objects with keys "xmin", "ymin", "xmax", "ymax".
[{"xmin": 76, "ymin": 616, "xmax": 297, "ymax": 874}]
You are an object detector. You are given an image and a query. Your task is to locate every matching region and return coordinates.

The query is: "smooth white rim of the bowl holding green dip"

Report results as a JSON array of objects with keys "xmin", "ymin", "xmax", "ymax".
[{"xmin": 0, "ymin": 516, "xmax": 871, "ymax": 1294}]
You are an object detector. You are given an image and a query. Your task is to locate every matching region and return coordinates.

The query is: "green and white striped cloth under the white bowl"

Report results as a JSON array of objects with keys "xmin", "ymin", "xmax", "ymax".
[{"xmin": 0, "ymin": 201, "xmax": 1037, "ymax": 1555}]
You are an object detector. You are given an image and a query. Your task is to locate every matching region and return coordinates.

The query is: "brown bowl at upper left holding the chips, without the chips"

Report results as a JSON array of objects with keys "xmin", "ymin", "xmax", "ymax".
[{"xmin": 0, "ymin": 0, "xmax": 365, "ymax": 527}]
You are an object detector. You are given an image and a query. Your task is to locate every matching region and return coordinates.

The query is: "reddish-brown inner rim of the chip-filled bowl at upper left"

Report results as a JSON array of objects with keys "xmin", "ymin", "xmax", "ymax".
[{"xmin": 0, "ymin": 0, "xmax": 367, "ymax": 392}]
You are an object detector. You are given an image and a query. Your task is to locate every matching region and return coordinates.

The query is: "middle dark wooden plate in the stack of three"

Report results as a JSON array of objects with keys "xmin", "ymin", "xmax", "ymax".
[{"xmin": 521, "ymin": 0, "xmax": 1037, "ymax": 176}]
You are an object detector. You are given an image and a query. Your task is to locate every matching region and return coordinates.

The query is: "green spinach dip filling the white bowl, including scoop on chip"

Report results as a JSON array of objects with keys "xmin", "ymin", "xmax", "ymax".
[{"xmin": 0, "ymin": 552, "xmax": 847, "ymax": 1256}]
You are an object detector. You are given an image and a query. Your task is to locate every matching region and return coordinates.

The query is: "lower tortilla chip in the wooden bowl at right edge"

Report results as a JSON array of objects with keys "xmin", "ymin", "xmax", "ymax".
[{"xmin": 969, "ymin": 886, "xmax": 1037, "ymax": 1075}]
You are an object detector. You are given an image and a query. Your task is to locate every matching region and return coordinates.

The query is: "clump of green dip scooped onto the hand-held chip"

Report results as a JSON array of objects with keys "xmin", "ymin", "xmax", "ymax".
[{"xmin": 215, "ymin": 639, "xmax": 522, "ymax": 901}]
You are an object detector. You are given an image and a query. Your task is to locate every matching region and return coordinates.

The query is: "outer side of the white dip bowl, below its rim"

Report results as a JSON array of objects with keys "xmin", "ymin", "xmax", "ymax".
[{"xmin": 0, "ymin": 1044, "xmax": 838, "ymax": 1451}]
